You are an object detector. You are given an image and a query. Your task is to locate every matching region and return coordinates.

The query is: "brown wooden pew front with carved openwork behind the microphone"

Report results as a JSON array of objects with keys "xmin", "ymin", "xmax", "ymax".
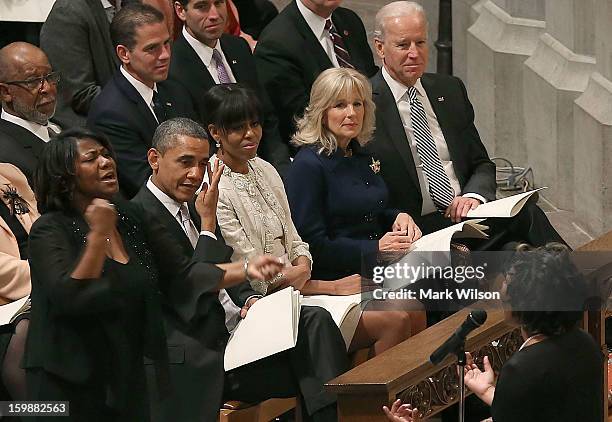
[{"xmin": 327, "ymin": 232, "xmax": 612, "ymax": 422}]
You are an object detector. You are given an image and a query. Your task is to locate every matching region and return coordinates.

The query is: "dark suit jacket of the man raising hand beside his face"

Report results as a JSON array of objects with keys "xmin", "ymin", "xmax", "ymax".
[{"xmin": 132, "ymin": 186, "xmax": 257, "ymax": 421}]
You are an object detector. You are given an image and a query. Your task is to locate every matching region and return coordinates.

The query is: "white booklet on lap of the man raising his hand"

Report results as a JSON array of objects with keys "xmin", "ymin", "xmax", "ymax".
[{"xmin": 223, "ymin": 287, "xmax": 300, "ymax": 371}]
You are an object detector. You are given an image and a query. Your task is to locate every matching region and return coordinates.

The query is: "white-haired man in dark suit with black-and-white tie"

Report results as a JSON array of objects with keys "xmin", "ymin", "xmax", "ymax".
[{"xmin": 371, "ymin": 1, "xmax": 564, "ymax": 248}]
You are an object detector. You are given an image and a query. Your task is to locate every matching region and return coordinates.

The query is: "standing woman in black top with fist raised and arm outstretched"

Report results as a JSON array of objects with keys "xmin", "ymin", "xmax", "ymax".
[{"xmin": 24, "ymin": 130, "xmax": 280, "ymax": 422}]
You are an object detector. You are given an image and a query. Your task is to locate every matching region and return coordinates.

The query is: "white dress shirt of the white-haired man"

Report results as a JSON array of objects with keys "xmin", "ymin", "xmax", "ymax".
[{"xmin": 382, "ymin": 67, "xmax": 486, "ymax": 215}]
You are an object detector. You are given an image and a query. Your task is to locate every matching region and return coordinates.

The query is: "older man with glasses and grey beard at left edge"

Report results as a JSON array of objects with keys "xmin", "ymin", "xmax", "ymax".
[{"xmin": 0, "ymin": 42, "xmax": 60, "ymax": 181}]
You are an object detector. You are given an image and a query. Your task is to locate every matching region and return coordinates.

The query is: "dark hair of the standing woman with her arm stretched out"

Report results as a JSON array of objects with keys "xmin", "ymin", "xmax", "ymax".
[{"xmin": 33, "ymin": 128, "xmax": 115, "ymax": 214}]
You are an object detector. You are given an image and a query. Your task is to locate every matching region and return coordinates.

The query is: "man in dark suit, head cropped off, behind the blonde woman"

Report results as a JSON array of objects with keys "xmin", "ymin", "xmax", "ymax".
[{"xmin": 255, "ymin": 0, "xmax": 377, "ymax": 143}]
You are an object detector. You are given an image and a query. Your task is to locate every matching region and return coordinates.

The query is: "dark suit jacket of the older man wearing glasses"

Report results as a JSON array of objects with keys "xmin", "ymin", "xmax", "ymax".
[{"xmin": 0, "ymin": 119, "xmax": 46, "ymax": 183}]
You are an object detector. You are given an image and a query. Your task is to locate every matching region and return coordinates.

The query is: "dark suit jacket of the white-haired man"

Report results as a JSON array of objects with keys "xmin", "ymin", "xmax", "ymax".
[{"xmin": 370, "ymin": 71, "xmax": 495, "ymax": 223}]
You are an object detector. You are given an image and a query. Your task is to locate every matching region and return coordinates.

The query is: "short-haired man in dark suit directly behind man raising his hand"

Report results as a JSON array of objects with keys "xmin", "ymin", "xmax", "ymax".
[{"xmin": 87, "ymin": 3, "xmax": 193, "ymax": 198}]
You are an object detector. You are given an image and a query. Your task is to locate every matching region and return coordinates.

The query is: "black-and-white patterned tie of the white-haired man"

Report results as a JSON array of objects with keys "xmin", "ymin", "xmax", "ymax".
[{"xmin": 408, "ymin": 86, "xmax": 455, "ymax": 212}]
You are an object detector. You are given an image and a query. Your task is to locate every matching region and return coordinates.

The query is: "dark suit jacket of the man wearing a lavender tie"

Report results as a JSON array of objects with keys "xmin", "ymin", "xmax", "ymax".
[{"xmin": 169, "ymin": 34, "xmax": 289, "ymax": 174}]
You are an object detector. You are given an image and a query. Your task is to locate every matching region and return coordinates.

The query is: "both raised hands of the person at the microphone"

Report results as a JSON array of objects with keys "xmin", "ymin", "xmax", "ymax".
[{"xmin": 383, "ymin": 352, "xmax": 495, "ymax": 422}]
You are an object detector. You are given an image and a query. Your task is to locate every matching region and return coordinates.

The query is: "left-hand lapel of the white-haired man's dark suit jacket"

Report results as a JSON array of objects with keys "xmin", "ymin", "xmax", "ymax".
[{"xmin": 372, "ymin": 71, "xmax": 419, "ymax": 186}]
